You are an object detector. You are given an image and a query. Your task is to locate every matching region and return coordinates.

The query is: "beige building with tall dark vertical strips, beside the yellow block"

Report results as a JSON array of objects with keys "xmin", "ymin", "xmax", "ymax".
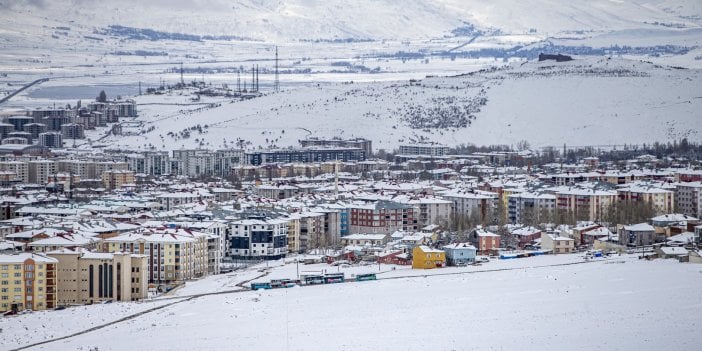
[{"xmin": 47, "ymin": 249, "xmax": 148, "ymax": 305}]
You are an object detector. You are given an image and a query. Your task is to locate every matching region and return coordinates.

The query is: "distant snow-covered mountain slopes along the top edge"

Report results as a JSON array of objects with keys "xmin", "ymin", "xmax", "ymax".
[{"xmin": 0, "ymin": 0, "xmax": 702, "ymax": 41}]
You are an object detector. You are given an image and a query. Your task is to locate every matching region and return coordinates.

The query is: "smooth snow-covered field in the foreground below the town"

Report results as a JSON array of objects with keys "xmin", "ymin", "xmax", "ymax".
[{"xmin": 3, "ymin": 255, "xmax": 702, "ymax": 350}]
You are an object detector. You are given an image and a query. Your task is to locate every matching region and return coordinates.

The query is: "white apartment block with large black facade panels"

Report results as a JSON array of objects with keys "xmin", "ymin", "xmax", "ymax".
[{"xmin": 229, "ymin": 216, "xmax": 288, "ymax": 260}]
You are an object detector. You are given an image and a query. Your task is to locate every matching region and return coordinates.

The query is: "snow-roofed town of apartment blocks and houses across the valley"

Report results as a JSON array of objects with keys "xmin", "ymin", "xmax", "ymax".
[{"xmin": 0, "ymin": 97, "xmax": 702, "ymax": 315}]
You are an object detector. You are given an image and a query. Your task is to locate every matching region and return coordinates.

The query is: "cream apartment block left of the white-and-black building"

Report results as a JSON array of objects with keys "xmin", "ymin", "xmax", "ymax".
[{"xmin": 105, "ymin": 228, "xmax": 208, "ymax": 284}]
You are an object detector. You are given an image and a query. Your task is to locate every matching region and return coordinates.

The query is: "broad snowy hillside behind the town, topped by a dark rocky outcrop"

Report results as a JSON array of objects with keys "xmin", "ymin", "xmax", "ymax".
[{"xmin": 93, "ymin": 58, "xmax": 702, "ymax": 150}]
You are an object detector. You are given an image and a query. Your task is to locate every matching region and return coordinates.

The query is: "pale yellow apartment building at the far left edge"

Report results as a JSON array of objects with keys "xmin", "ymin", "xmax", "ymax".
[{"xmin": 0, "ymin": 253, "xmax": 58, "ymax": 312}]
